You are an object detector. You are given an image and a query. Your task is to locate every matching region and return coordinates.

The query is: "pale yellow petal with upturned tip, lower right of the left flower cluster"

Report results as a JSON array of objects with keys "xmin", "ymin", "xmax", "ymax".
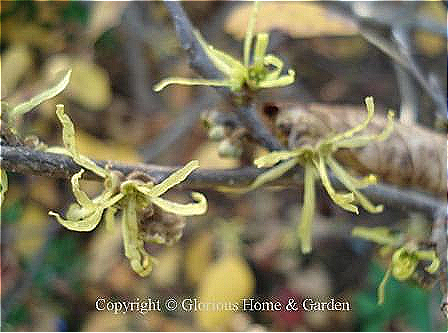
[{"xmin": 151, "ymin": 192, "xmax": 207, "ymax": 216}]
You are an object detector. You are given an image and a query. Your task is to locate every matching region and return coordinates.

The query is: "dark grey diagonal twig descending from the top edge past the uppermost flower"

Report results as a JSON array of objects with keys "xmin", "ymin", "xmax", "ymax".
[{"xmin": 165, "ymin": 1, "xmax": 283, "ymax": 151}]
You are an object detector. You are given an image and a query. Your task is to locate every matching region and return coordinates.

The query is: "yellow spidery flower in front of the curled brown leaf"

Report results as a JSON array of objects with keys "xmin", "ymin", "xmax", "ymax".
[{"xmin": 224, "ymin": 97, "xmax": 394, "ymax": 253}]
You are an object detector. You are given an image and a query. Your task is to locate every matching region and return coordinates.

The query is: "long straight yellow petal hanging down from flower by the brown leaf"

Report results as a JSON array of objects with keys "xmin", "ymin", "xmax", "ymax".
[{"xmin": 299, "ymin": 163, "xmax": 316, "ymax": 253}]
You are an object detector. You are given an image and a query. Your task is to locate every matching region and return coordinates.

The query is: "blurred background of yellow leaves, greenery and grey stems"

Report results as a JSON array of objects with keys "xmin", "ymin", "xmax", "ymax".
[{"xmin": 0, "ymin": 1, "xmax": 447, "ymax": 332}]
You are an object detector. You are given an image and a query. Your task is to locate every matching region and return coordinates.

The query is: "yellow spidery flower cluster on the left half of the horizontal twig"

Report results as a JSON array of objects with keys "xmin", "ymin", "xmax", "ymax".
[{"xmin": 49, "ymin": 105, "xmax": 207, "ymax": 276}]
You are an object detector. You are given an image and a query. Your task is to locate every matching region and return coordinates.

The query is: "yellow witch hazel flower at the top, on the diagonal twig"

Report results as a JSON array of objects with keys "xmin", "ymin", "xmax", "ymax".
[{"xmin": 154, "ymin": 2, "xmax": 295, "ymax": 92}]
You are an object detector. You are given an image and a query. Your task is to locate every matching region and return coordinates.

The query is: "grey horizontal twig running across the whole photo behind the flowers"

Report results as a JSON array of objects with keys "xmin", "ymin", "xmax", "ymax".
[{"xmin": 0, "ymin": 146, "xmax": 446, "ymax": 217}]
